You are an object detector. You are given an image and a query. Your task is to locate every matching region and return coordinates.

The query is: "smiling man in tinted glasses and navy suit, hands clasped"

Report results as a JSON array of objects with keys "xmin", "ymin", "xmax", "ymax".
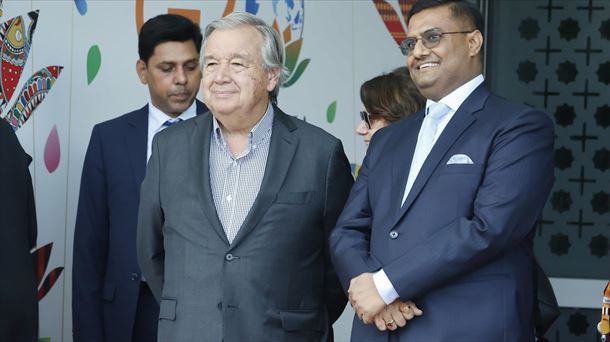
[{"xmin": 331, "ymin": 0, "xmax": 553, "ymax": 341}]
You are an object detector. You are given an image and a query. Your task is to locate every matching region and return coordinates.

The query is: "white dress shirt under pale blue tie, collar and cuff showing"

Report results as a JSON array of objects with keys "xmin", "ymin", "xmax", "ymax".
[{"xmin": 373, "ymin": 75, "xmax": 485, "ymax": 304}]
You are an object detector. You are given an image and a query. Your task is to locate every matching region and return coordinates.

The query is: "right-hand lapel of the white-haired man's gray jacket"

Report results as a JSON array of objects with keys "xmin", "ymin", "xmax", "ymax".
[{"xmin": 231, "ymin": 106, "xmax": 298, "ymax": 247}]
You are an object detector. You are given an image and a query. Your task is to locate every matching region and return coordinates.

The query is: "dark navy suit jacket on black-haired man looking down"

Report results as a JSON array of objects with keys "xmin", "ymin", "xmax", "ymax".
[{"xmin": 72, "ymin": 101, "xmax": 207, "ymax": 341}]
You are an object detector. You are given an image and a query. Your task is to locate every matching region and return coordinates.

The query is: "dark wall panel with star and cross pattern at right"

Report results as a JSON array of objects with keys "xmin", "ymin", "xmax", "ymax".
[{"xmin": 487, "ymin": 0, "xmax": 610, "ymax": 341}]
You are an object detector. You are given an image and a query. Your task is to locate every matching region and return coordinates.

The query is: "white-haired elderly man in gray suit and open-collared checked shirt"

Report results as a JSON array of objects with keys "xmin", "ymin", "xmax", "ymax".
[{"xmin": 138, "ymin": 13, "xmax": 353, "ymax": 341}]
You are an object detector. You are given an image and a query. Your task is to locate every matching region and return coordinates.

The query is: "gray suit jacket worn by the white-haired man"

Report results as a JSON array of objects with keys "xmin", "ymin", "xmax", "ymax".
[{"xmin": 137, "ymin": 108, "xmax": 353, "ymax": 341}]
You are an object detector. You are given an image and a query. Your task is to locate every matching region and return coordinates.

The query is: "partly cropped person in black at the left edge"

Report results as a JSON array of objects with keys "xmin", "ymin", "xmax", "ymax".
[{"xmin": 0, "ymin": 118, "xmax": 38, "ymax": 341}]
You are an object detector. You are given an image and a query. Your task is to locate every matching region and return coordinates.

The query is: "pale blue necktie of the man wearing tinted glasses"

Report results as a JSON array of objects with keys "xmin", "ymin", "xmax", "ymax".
[{"xmin": 400, "ymin": 102, "xmax": 451, "ymax": 207}]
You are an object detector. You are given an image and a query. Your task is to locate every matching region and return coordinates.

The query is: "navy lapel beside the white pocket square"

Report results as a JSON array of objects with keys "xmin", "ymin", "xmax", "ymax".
[{"xmin": 391, "ymin": 84, "xmax": 489, "ymax": 227}]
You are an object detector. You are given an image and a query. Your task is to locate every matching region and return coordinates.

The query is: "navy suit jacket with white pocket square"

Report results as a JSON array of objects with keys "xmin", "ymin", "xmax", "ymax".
[{"xmin": 331, "ymin": 85, "xmax": 554, "ymax": 341}]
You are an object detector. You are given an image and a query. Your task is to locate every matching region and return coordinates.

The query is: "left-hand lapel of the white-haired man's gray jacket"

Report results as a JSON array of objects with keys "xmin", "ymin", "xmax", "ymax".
[{"xmin": 188, "ymin": 113, "xmax": 229, "ymax": 246}]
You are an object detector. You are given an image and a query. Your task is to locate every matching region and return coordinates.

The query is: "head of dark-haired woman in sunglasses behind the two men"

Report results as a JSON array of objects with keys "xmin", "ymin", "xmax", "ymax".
[{"xmin": 356, "ymin": 67, "xmax": 426, "ymax": 145}]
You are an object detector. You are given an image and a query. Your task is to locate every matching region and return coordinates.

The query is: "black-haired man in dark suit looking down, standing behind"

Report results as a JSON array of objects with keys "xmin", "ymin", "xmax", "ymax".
[{"xmin": 72, "ymin": 15, "xmax": 207, "ymax": 342}]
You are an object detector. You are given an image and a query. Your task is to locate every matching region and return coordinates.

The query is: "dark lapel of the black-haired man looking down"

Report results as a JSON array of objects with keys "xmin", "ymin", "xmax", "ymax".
[{"xmin": 125, "ymin": 105, "xmax": 148, "ymax": 194}]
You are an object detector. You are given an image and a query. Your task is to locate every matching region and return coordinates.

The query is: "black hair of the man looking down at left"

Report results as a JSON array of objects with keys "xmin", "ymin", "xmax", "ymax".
[{"xmin": 138, "ymin": 14, "xmax": 203, "ymax": 63}]
